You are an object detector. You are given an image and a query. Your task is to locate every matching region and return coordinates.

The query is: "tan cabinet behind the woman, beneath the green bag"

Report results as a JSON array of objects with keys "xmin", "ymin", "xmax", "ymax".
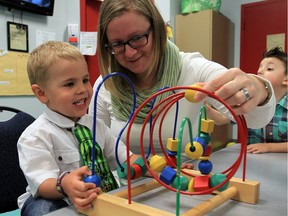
[{"xmin": 175, "ymin": 10, "xmax": 234, "ymax": 151}]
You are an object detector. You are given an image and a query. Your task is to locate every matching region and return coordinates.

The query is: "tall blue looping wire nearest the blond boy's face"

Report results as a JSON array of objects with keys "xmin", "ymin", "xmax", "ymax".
[{"xmin": 92, "ymin": 72, "xmax": 136, "ymax": 175}]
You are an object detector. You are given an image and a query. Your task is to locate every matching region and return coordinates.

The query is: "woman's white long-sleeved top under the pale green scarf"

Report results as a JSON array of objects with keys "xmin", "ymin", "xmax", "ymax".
[{"xmin": 89, "ymin": 52, "xmax": 275, "ymax": 153}]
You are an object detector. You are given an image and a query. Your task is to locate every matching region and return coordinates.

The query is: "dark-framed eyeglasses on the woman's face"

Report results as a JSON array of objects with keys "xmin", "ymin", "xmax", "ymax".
[{"xmin": 105, "ymin": 28, "xmax": 152, "ymax": 55}]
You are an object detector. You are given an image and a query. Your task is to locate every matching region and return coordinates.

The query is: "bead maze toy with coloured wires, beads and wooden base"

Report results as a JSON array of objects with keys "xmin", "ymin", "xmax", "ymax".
[{"xmin": 80, "ymin": 73, "xmax": 260, "ymax": 216}]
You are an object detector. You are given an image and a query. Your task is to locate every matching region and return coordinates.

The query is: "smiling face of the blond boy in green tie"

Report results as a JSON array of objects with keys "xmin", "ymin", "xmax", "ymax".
[{"xmin": 38, "ymin": 59, "xmax": 93, "ymax": 122}]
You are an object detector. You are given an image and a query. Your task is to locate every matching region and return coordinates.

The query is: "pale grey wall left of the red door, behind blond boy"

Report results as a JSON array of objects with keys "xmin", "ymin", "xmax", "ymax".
[{"xmin": 0, "ymin": 0, "xmax": 80, "ymax": 120}]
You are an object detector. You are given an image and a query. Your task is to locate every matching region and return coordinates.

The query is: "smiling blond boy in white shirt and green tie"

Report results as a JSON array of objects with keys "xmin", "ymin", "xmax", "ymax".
[{"xmin": 18, "ymin": 41, "xmax": 138, "ymax": 216}]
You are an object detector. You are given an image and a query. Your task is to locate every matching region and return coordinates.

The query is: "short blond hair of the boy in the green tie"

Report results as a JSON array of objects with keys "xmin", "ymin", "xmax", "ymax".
[{"xmin": 27, "ymin": 41, "xmax": 85, "ymax": 86}]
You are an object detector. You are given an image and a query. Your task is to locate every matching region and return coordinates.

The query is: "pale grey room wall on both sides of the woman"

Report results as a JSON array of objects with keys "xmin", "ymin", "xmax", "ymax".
[{"xmin": 0, "ymin": 0, "xmax": 261, "ymax": 120}]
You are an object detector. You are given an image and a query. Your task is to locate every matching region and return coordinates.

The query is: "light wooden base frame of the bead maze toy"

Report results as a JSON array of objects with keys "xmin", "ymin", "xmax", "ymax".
[{"xmin": 80, "ymin": 170, "xmax": 260, "ymax": 216}]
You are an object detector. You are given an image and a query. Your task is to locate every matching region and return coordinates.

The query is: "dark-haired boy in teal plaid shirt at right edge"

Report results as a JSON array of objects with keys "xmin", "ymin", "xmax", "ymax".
[{"xmin": 206, "ymin": 47, "xmax": 288, "ymax": 153}]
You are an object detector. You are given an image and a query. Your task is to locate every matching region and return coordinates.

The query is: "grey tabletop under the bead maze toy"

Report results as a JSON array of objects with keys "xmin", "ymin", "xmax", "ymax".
[{"xmin": 45, "ymin": 144, "xmax": 287, "ymax": 216}]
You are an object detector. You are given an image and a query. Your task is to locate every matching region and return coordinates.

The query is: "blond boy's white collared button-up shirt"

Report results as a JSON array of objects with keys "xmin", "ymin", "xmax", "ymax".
[{"xmin": 17, "ymin": 109, "xmax": 132, "ymax": 209}]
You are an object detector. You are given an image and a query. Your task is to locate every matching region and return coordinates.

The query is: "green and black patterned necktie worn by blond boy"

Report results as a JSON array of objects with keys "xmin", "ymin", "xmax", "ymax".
[{"xmin": 72, "ymin": 125, "xmax": 118, "ymax": 192}]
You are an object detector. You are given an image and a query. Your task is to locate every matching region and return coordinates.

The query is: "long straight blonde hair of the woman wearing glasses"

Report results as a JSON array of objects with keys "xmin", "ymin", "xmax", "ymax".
[{"xmin": 97, "ymin": 0, "xmax": 167, "ymax": 97}]
